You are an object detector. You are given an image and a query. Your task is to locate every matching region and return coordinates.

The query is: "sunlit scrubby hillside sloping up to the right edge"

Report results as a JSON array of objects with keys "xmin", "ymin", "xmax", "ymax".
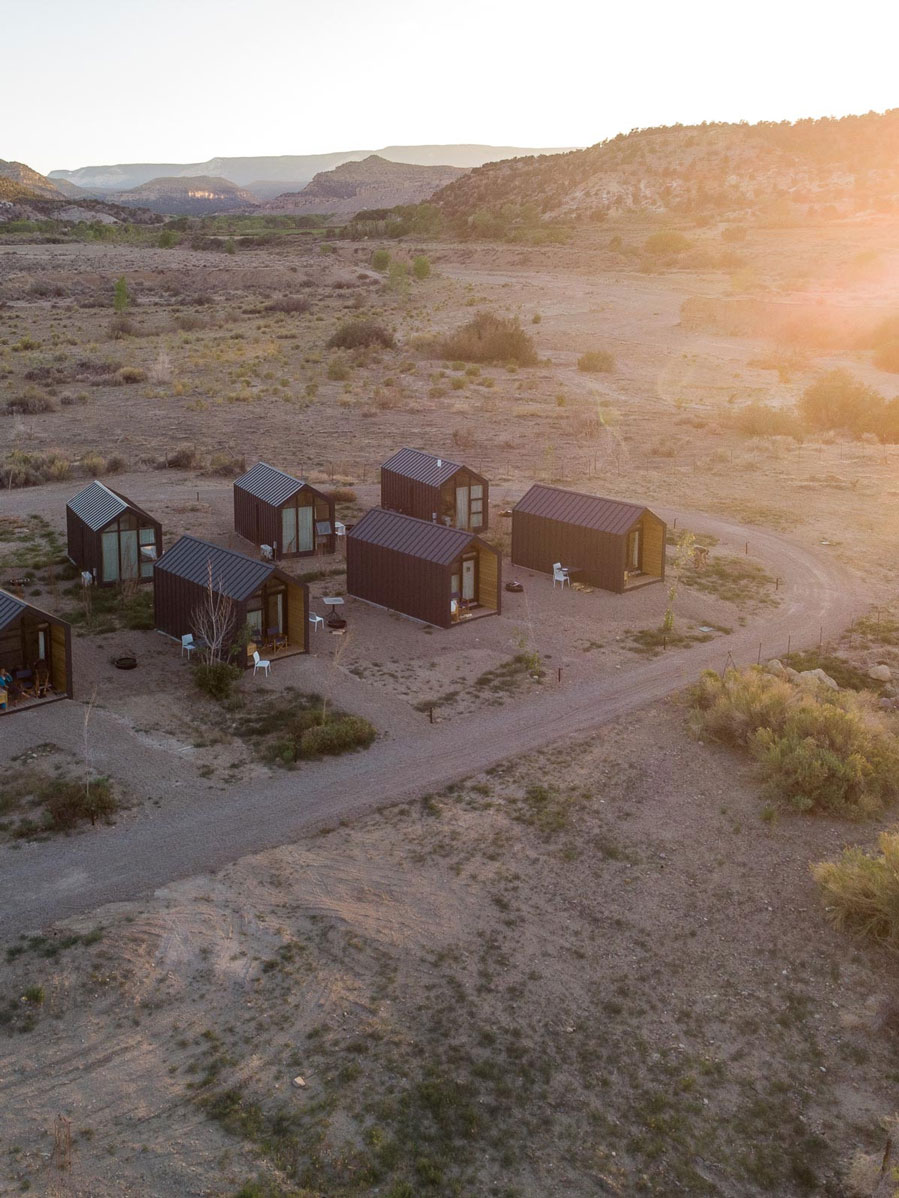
[{"xmin": 426, "ymin": 109, "xmax": 899, "ymax": 222}]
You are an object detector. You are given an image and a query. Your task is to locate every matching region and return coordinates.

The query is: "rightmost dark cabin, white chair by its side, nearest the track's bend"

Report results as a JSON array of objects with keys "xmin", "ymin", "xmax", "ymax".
[{"xmin": 512, "ymin": 483, "xmax": 665, "ymax": 593}]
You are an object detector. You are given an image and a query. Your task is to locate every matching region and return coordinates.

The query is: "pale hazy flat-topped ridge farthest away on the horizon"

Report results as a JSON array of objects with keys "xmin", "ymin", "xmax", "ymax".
[{"xmin": 47, "ymin": 145, "xmax": 572, "ymax": 199}]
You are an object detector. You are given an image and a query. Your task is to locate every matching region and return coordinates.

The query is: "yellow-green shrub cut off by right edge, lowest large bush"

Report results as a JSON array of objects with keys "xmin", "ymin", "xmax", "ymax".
[{"xmin": 811, "ymin": 831, "xmax": 899, "ymax": 950}]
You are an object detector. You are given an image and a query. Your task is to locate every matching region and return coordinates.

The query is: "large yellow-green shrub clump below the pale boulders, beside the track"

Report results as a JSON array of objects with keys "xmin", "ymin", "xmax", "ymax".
[{"xmin": 690, "ymin": 668, "xmax": 899, "ymax": 816}]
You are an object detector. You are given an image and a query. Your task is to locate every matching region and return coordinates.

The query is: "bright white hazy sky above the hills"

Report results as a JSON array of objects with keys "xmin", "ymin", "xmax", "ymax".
[{"xmin": 7, "ymin": 0, "xmax": 899, "ymax": 173}]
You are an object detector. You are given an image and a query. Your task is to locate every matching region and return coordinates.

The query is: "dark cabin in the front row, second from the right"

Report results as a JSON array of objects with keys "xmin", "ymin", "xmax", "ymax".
[{"xmin": 346, "ymin": 508, "xmax": 502, "ymax": 628}]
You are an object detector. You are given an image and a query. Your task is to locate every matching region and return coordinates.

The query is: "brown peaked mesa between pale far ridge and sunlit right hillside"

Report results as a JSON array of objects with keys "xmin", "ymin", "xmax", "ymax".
[{"xmin": 263, "ymin": 153, "xmax": 466, "ymax": 216}]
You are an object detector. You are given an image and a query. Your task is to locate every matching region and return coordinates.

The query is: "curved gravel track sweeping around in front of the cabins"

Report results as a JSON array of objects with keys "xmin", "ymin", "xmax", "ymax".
[{"xmin": 0, "ymin": 512, "xmax": 867, "ymax": 937}]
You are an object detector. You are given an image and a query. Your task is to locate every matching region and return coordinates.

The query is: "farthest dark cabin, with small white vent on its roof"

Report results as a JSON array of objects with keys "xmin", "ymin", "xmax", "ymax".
[{"xmin": 381, "ymin": 449, "xmax": 490, "ymax": 532}]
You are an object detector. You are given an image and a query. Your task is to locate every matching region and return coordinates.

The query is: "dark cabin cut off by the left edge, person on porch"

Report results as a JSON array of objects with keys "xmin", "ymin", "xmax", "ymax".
[{"xmin": 0, "ymin": 591, "xmax": 72, "ymax": 714}]
